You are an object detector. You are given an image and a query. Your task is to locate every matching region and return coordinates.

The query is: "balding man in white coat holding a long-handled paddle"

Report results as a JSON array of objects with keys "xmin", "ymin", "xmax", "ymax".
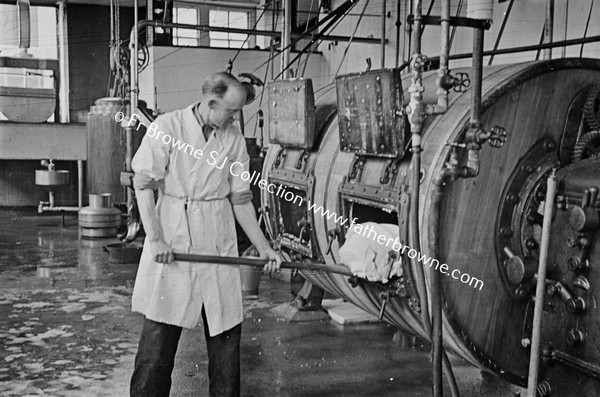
[{"xmin": 130, "ymin": 73, "xmax": 281, "ymax": 397}]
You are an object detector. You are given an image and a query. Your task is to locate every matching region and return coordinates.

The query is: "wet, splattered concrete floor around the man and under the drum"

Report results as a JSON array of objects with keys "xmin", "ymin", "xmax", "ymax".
[{"xmin": 0, "ymin": 209, "xmax": 524, "ymax": 397}]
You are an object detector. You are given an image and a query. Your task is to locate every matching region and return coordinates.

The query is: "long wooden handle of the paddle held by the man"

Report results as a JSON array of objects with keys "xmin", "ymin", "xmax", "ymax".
[{"xmin": 155, "ymin": 252, "xmax": 353, "ymax": 277}]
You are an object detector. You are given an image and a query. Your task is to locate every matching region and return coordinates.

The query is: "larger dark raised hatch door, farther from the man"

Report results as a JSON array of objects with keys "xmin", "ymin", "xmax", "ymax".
[{"xmin": 336, "ymin": 69, "xmax": 408, "ymax": 158}]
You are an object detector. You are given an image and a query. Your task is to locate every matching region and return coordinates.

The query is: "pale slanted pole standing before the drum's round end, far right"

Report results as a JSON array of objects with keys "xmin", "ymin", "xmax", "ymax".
[{"xmin": 527, "ymin": 170, "xmax": 556, "ymax": 397}]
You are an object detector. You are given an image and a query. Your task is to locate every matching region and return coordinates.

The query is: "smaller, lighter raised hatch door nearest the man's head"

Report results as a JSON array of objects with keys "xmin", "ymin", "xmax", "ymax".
[{"xmin": 268, "ymin": 79, "xmax": 315, "ymax": 150}]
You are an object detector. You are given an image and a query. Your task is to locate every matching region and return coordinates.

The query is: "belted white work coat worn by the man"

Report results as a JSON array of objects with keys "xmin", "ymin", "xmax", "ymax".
[{"xmin": 132, "ymin": 103, "xmax": 250, "ymax": 336}]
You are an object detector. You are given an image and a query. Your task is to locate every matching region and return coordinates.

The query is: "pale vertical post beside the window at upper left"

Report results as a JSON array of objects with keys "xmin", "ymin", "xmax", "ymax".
[{"xmin": 57, "ymin": 0, "xmax": 70, "ymax": 123}]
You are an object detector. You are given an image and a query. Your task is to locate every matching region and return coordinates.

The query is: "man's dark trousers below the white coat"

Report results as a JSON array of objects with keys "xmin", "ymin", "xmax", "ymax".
[{"xmin": 129, "ymin": 309, "xmax": 242, "ymax": 397}]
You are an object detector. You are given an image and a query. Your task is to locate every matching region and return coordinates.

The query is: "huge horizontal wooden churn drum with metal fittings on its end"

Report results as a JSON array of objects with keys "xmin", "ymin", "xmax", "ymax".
[{"xmin": 262, "ymin": 59, "xmax": 600, "ymax": 396}]
